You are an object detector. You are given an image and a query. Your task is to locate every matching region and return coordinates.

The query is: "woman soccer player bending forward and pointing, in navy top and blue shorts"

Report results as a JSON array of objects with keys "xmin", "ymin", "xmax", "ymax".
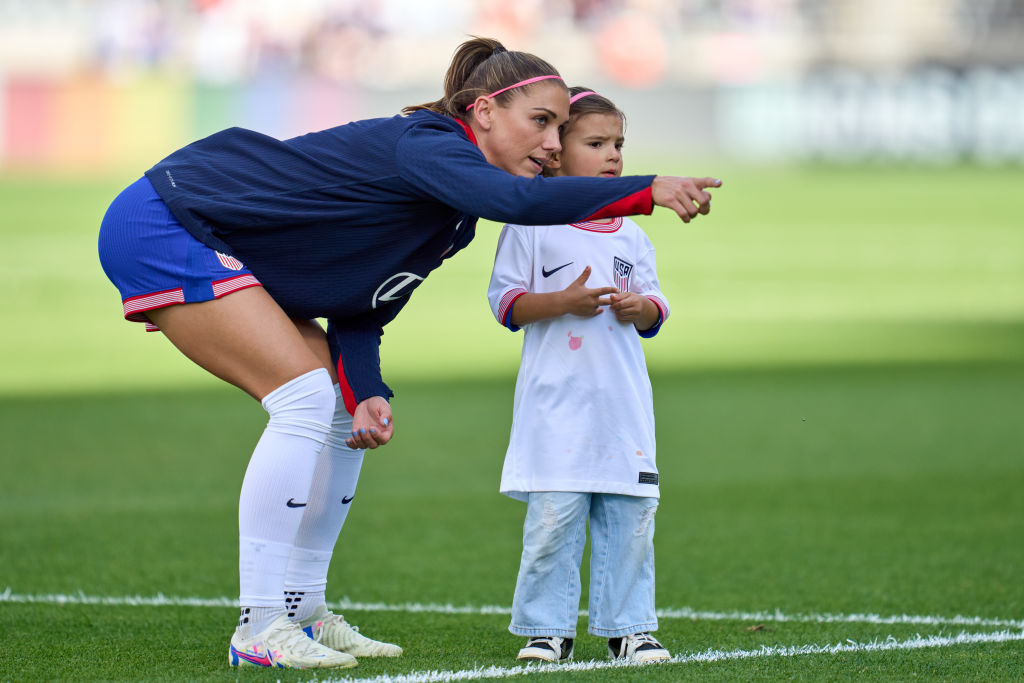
[{"xmin": 99, "ymin": 38, "xmax": 715, "ymax": 668}]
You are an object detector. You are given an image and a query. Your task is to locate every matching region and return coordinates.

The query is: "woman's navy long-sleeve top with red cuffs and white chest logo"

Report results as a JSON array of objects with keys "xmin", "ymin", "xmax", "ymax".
[{"xmin": 145, "ymin": 111, "xmax": 654, "ymax": 411}]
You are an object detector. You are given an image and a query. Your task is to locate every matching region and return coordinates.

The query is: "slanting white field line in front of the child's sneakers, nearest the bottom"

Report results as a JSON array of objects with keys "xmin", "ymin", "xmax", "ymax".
[{"xmin": 318, "ymin": 631, "xmax": 1024, "ymax": 683}]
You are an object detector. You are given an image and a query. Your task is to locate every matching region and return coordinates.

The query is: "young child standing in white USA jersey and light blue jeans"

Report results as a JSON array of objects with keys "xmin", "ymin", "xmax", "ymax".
[{"xmin": 487, "ymin": 87, "xmax": 670, "ymax": 661}]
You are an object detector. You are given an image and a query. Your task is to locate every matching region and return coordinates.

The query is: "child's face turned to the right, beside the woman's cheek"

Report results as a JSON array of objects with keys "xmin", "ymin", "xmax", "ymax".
[{"xmin": 548, "ymin": 114, "xmax": 625, "ymax": 178}]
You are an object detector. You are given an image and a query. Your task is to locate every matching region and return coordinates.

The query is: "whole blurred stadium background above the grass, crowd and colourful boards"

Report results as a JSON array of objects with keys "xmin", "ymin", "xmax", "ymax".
[{"xmin": 0, "ymin": 0, "xmax": 1024, "ymax": 175}]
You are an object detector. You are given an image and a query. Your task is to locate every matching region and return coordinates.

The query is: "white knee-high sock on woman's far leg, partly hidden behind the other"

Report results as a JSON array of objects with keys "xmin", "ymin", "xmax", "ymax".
[{"xmin": 285, "ymin": 385, "xmax": 364, "ymax": 621}]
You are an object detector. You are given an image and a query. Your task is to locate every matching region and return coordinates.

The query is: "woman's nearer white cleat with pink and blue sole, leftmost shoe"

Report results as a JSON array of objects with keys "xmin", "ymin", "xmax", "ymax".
[{"xmin": 227, "ymin": 614, "xmax": 358, "ymax": 669}]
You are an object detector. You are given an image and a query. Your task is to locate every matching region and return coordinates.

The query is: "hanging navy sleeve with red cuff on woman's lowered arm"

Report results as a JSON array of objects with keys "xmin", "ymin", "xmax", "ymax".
[{"xmin": 327, "ymin": 315, "xmax": 394, "ymax": 415}]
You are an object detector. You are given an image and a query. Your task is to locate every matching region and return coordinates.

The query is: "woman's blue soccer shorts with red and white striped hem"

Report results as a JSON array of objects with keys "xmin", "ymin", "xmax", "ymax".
[{"xmin": 99, "ymin": 176, "xmax": 260, "ymax": 331}]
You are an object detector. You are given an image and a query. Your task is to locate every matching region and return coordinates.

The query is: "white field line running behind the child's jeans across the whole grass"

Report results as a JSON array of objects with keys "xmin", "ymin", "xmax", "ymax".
[{"xmin": 0, "ymin": 588, "xmax": 1024, "ymax": 630}]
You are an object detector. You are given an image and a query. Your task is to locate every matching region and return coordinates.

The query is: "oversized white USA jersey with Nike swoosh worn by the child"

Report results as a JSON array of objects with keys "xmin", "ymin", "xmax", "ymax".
[{"xmin": 487, "ymin": 218, "xmax": 669, "ymax": 500}]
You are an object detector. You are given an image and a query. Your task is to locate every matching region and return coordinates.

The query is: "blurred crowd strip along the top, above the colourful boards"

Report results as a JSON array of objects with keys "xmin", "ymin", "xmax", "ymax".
[{"xmin": 0, "ymin": 0, "xmax": 1024, "ymax": 89}]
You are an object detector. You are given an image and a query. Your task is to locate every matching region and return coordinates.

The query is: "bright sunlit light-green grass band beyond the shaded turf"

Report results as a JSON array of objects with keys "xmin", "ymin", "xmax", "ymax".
[{"xmin": 0, "ymin": 159, "xmax": 1024, "ymax": 395}]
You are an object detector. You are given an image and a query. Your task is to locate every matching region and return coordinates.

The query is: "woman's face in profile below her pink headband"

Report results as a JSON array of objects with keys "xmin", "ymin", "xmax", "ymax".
[{"xmin": 470, "ymin": 82, "xmax": 569, "ymax": 178}]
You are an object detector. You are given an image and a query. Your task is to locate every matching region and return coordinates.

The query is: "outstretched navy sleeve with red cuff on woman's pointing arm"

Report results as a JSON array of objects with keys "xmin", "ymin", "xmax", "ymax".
[{"xmin": 396, "ymin": 121, "xmax": 654, "ymax": 225}]
